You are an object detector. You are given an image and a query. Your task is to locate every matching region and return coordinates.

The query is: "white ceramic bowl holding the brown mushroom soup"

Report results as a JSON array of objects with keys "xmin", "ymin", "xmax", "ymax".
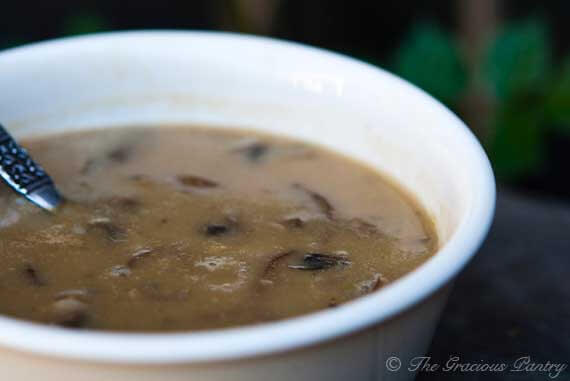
[{"xmin": 0, "ymin": 32, "xmax": 495, "ymax": 381}]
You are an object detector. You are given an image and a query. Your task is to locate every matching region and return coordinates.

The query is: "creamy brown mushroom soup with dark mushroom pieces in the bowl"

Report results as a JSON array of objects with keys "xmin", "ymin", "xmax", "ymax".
[{"xmin": 0, "ymin": 127, "xmax": 437, "ymax": 331}]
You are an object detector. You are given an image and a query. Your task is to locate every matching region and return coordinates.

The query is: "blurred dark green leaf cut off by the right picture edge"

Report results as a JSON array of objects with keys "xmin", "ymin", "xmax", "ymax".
[{"xmin": 546, "ymin": 57, "xmax": 570, "ymax": 133}]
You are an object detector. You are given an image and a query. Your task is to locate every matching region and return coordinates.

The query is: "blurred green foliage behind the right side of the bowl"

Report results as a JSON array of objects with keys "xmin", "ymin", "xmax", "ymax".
[{"xmin": 393, "ymin": 20, "xmax": 570, "ymax": 182}]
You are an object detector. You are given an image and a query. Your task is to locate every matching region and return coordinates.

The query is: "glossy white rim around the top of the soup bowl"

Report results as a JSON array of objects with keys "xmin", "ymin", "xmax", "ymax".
[{"xmin": 0, "ymin": 30, "xmax": 495, "ymax": 364}]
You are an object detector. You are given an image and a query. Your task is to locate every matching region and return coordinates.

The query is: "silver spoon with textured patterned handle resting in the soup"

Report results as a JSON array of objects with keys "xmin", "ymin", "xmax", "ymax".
[{"xmin": 0, "ymin": 125, "xmax": 62, "ymax": 212}]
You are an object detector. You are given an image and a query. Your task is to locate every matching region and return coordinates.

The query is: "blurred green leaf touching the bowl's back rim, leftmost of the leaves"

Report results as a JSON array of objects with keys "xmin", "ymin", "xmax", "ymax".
[{"xmin": 394, "ymin": 24, "xmax": 467, "ymax": 105}]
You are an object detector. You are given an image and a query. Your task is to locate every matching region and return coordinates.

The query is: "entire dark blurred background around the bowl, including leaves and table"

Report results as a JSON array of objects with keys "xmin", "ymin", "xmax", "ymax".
[{"xmin": 0, "ymin": 0, "xmax": 570, "ymax": 381}]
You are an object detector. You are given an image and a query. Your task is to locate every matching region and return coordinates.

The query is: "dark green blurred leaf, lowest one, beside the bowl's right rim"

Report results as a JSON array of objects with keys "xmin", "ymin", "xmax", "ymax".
[{"xmin": 488, "ymin": 98, "xmax": 545, "ymax": 181}]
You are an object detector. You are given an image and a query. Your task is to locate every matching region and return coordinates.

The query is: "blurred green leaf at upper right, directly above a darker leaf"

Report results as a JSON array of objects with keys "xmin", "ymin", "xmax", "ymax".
[{"xmin": 484, "ymin": 21, "xmax": 551, "ymax": 100}]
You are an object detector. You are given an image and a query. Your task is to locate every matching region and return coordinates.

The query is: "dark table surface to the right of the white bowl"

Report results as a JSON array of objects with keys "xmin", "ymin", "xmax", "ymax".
[{"xmin": 417, "ymin": 189, "xmax": 570, "ymax": 381}]
